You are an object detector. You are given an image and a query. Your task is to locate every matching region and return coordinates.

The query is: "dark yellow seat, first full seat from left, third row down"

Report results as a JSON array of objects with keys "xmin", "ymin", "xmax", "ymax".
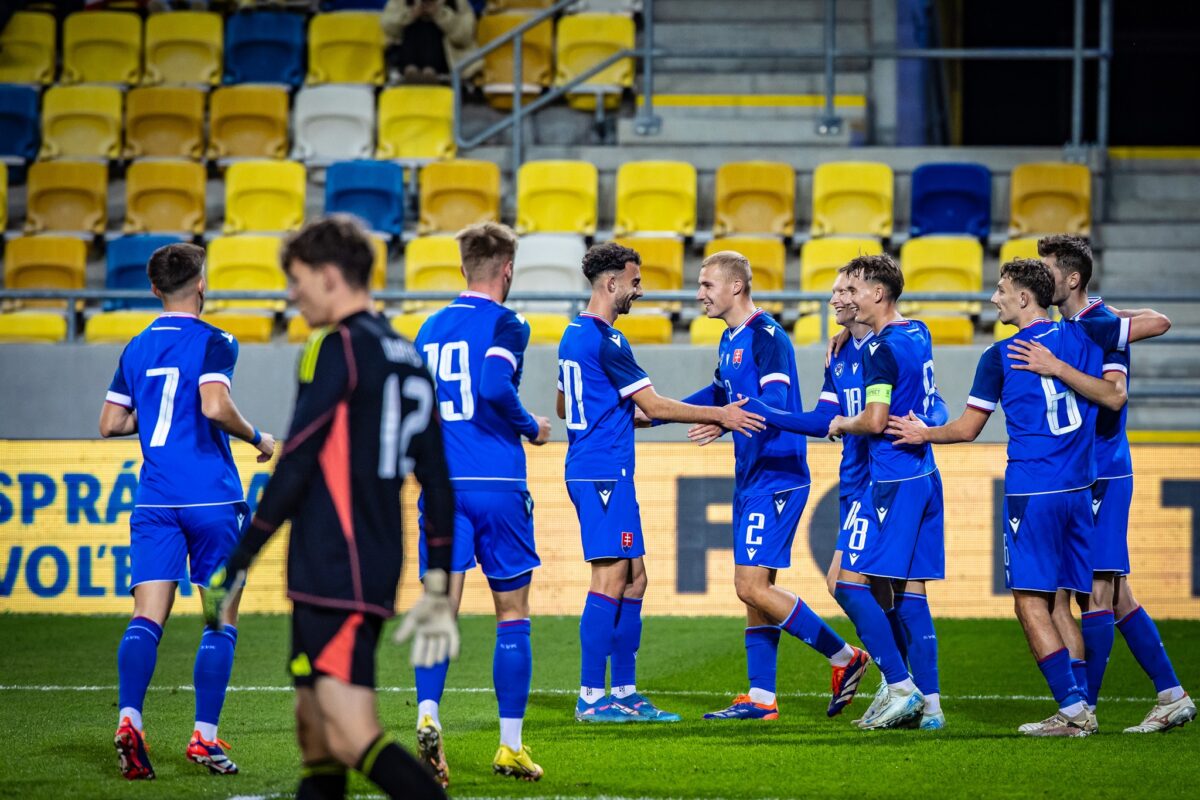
[{"xmin": 25, "ymin": 161, "xmax": 108, "ymax": 234}]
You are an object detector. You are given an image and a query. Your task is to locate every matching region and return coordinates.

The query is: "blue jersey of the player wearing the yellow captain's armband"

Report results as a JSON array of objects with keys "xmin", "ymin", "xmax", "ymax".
[{"xmin": 862, "ymin": 319, "xmax": 937, "ymax": 481}]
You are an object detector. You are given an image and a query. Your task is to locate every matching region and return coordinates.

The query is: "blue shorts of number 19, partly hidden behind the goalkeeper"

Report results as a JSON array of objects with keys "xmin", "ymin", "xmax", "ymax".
[{"xmin": 416, "ymin": 491, "xmax": 541, "ymax": 591}]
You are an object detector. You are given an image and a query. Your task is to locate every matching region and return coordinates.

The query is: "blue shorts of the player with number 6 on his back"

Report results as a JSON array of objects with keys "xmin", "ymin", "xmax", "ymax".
[{"xmin": 1004, "ymin": 489, "xmax": 1092, "ymax": 593}]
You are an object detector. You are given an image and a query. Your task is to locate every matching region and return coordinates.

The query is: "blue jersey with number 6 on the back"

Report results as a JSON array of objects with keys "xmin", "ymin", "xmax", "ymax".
[{"xmin": 967, "ymin": 318, "xmax": 1102, "ymax": 494}]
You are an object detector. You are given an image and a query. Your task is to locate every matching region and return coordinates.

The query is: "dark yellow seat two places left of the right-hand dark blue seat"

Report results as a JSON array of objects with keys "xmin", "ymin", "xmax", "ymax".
[{"xmin": 713, "ymin": 161, "xmax": 796, "ymax": 236}]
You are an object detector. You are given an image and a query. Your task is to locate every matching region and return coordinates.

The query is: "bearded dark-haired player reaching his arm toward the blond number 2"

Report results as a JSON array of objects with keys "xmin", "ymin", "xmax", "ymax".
[{"xmin": 557, "ymin": 242, "xmax": 763, "ymax": 722}]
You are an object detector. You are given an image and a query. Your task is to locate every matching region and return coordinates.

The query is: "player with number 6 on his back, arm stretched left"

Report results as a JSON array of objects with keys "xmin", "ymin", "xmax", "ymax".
[{"xmin": 888, "ymin": 259, "xmax": 1128, "ymax": 736}]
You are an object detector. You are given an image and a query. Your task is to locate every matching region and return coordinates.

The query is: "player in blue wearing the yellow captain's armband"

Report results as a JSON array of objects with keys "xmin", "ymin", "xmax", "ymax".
[{"xmin": 829, "ymin": 255, "xmax": 946, "ymax": 729}]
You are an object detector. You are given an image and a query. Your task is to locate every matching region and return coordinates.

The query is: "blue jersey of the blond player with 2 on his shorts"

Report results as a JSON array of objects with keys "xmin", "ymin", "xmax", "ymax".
[{"xmin": 715, "ymin": 308, "xmax": 809, "ymax": 495}]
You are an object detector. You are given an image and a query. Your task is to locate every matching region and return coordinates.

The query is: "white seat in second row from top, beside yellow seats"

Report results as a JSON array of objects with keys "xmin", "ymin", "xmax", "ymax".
[{"xmin": 292, "ymin": 85, "xmax": 376, "ymax": 163}]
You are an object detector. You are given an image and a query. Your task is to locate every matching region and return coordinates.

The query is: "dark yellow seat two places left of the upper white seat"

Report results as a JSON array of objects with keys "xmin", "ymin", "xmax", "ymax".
[{"xmin": 125, "ymin": 86, "xmax": 204, "ymax": 158}]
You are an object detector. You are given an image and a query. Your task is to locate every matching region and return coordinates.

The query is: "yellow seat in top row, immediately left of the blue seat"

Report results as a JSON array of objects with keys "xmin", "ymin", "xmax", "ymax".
[{"xmin": 143, "ymin": 11, "xmax": 224, "ymax": 85}]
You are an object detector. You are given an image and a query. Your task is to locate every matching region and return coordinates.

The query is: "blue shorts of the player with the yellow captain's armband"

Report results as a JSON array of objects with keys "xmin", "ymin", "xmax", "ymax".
[{"xmin": 859, "ymin": 470, "xmax": 946, "ymax": 581}]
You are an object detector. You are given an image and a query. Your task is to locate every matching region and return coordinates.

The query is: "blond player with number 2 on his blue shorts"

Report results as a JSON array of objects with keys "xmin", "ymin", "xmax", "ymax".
[{"xmin": 684, "ymin": 251, "xmax": 871, "ymax": 720}]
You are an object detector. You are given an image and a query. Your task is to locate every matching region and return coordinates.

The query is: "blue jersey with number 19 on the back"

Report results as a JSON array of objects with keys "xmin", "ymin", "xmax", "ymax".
[{"xmin": 416, "ymin": 291, "xmax": 538, "ymax": 491}]
